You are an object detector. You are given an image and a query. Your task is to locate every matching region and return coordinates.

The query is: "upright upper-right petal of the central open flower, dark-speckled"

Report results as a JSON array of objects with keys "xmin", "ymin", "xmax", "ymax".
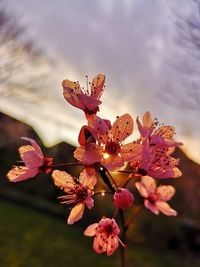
[{"xmin": 111, "ymin": 113, "xmax": 133, "ymax": 143}]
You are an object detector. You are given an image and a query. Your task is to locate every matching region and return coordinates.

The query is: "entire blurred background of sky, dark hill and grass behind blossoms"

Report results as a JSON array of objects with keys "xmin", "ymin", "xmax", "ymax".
[{"xmin": 0, "ymin": 0, "xmax": 200, "ymax": 267}]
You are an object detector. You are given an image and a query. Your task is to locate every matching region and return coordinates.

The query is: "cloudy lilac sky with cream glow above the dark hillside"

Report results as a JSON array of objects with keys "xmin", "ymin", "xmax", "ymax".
[{"xmin": 0, "ymin": 0, "xmax": 200, "ymax": 163}]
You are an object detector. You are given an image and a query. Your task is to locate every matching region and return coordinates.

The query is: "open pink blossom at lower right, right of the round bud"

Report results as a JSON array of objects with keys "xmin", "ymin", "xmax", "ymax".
[{"xmin": 135, "ymin": 176, "xmax": 177, "ymax": 216}]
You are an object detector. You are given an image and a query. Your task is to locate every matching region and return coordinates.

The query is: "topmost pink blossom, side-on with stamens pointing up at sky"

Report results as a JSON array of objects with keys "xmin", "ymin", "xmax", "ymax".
[{"xmin": 62, "ymin": 74, "xmax": 105, "ymax": 115}]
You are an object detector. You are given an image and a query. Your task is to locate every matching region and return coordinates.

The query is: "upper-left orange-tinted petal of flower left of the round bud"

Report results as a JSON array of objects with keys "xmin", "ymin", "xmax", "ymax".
[{"xmin": 52, "ymin": 170, "xmax": 75, "ymax": 191}]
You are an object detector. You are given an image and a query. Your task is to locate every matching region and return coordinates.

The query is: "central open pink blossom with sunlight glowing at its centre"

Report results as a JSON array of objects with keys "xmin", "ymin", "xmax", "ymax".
[{"xmin": 74, "ymin": 114, "xmax": 141, "ymax": 170}]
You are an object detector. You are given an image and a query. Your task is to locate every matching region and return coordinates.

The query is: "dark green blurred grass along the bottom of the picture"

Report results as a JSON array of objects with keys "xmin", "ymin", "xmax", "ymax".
[{"xmin": 0, "ymin": 201, "xmax": 200, "ymax": 267}]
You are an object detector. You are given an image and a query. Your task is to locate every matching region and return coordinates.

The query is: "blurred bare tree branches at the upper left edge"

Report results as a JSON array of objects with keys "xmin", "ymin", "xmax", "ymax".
[{"xmin": 0, "ymin": 1, "xmax": 52, "ymax": 102}]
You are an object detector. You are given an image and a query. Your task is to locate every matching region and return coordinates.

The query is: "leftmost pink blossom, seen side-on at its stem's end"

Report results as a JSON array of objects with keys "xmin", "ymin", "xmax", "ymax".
[{"xmin": 7, "ymin": 137, "xmax": 53, "ymax": 182}]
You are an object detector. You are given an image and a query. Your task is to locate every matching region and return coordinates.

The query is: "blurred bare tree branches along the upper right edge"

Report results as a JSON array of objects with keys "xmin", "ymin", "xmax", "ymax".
[{"xmin": 161, "ymin": 0, "xmax": 200, "ymax": 110}]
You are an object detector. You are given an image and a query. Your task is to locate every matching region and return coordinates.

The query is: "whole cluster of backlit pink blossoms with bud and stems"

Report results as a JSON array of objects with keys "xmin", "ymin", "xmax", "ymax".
[{"xmin": 7, "ymin": 74, "xmax": 182, "ymax": 256}]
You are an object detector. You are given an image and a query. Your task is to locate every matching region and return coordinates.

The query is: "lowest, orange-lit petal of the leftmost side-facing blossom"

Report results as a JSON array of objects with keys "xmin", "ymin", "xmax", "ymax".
[{"xmin": 7, "ymin": 166, "xmax": 38, "ymax": 182}]
